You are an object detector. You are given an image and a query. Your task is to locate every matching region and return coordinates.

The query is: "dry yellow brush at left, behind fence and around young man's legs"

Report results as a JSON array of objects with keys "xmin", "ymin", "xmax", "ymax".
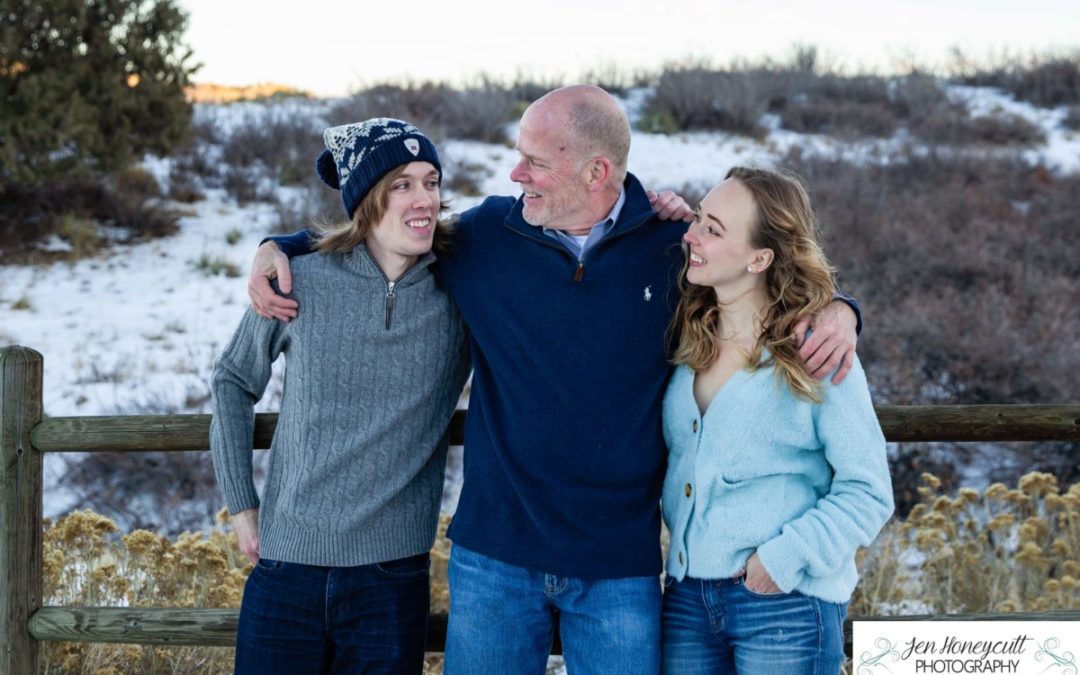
[{"xmin": 42, "ymin": 510, "xmax": 450, "ymax": 675}]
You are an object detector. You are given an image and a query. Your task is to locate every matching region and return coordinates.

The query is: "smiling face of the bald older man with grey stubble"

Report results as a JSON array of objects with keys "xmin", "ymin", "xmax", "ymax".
[{"xmin": 510, "ymin": 104, "xmax": 592, "ymax": 230}]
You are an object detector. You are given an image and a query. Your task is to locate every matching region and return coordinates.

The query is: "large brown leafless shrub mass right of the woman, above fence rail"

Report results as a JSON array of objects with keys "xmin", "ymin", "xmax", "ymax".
[{"xmin": 785, "ymin": 149, "xmax": 1080, "ymax": 403}]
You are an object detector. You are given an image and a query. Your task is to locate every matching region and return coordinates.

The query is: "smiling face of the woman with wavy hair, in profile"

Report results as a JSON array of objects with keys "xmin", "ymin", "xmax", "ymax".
[{"xmin": 683, "ymin": 178, "xmax": 772, "ymax": 299}]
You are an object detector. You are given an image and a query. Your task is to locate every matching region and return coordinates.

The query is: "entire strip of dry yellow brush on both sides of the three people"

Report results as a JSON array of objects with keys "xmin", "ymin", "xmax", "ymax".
[{"xmin": 38, "ymin": 472, "xmax": 1080, "ymax": 675}]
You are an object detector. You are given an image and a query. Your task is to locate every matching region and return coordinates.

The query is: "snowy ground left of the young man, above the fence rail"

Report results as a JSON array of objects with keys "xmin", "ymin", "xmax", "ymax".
[{"xmin": 0, "ymin": 193, "xmax": 272, "ymax": 416}]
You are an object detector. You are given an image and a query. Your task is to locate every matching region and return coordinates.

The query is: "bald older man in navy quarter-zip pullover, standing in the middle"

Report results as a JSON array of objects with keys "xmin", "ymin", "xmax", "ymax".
[{"xmin": 249, "ymin": 85, "xmax": 855, "ymax": 675}]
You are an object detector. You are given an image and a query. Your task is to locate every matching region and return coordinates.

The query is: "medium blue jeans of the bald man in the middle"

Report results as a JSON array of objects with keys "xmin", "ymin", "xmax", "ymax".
[{"xmin": 444, "ymin": 545, "xmax": 660, "ymax": 675}]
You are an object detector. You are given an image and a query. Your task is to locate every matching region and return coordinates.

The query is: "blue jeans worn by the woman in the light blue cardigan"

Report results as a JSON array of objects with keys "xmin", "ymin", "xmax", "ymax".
[{"xmin": 662, "ymin": 577, "xmax": 848, "ymax": 675}]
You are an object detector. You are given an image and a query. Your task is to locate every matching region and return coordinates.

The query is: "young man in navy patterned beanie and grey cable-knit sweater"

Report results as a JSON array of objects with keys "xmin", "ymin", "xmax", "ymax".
[{"xmin": 211, "ymin": 119, "xmax": 469, "ymax": 675}]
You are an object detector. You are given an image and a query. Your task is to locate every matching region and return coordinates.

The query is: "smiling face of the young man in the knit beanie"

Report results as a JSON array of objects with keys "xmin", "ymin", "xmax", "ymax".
[{"xmin": 364, "ymin": 162, "xmax": 440, "ymax": 280}]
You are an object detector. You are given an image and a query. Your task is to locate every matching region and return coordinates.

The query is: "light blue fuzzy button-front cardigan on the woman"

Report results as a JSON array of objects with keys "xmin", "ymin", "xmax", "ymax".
[{"xmin": 663, "ymin": 359, "xmax": 893, "ymax": 603}]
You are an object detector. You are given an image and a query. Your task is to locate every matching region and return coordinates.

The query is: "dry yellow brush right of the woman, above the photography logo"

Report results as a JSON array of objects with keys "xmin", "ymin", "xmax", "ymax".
[{"xmin": 849, "ymin": 472, "xmax": 1080, "ymax": 616}]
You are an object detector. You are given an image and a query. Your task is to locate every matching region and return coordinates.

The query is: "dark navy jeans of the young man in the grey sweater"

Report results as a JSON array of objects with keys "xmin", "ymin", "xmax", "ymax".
[{"xmin": 235, "ymin": 553, "xmax": 430, "ymax": 675}]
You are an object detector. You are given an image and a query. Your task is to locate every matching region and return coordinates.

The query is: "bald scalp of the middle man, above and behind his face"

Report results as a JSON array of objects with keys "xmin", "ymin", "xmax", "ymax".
[{"xmin": 522, "ymin": 84, "xmax": 630, "ymax": 186}]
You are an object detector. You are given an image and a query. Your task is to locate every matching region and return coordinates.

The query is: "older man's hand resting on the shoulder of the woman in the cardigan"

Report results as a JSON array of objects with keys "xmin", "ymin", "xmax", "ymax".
[{"xmin": 795, "ymin": 300, "xmax": 859, "ymax": 384}]
